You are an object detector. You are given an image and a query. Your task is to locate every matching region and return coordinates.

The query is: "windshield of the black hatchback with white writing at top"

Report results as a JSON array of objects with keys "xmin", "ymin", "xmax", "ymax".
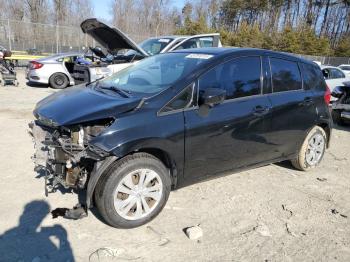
[{"xmin": 98, "ymin": 53, "xmax": 212, "ymax": 94}]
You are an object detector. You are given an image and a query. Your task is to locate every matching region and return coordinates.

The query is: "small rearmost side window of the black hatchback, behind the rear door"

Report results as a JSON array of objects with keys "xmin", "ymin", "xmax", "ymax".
[{"xmin": 300, "ymin": 63, "xmax": 326, "ymax": 90}]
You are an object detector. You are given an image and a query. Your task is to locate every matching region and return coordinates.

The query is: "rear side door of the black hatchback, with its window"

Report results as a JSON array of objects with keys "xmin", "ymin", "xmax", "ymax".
[{"xmin": 268, "ymin": 57, "xmax": 316, "ymax": 159}]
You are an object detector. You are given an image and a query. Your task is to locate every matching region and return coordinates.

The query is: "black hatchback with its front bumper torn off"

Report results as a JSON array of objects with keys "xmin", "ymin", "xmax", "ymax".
[{"xmin": 31, "ymin": 48, "xmax": 331, "ymax": 228}]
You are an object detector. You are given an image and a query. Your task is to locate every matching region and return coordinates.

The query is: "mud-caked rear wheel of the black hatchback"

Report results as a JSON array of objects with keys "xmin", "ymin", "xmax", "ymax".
[{"xmin": 291, "ymin": 126, "xmax": 327, "ymax": 171}]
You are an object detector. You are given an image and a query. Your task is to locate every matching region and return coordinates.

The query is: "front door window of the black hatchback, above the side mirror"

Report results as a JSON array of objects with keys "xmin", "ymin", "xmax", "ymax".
[{"xmin": 199, "ymin": 56, "xmax": 261, "ymax": 100}]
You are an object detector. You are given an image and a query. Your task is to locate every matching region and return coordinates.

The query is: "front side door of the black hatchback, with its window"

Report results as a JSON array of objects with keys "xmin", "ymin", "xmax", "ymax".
[{"xmin": 184, "ymin": 56, "xmax": 271, "ymax": 180}]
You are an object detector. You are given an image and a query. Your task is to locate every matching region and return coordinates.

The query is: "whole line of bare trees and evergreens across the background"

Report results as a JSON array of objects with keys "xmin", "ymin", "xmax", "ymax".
[{"xmin": 0, "ymin": 0, "xmax": 350, "ymax": 56}]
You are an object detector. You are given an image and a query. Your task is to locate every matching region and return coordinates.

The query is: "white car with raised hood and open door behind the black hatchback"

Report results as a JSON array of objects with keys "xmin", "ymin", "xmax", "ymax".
[{"xmin": 74, "ymin": 18, "xmax": 221, "ymax": 84}]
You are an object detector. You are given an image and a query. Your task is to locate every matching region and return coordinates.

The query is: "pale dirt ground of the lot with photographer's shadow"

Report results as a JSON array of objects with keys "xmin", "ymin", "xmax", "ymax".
[{"xmin": 0, "ymin": 69, "xmax": 350, "ymax": 262}]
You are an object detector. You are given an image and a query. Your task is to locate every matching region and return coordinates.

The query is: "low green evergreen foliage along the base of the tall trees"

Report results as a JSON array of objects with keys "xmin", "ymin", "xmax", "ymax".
[{"xmin": 175, "ymin": 17, "xmax": 332, "ymax": 56}]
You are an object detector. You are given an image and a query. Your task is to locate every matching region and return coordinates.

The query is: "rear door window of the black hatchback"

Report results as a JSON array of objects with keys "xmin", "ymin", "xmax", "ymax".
[{"xmin": 270, "ymin": 58, "xmax": 302, "ymax": 93}]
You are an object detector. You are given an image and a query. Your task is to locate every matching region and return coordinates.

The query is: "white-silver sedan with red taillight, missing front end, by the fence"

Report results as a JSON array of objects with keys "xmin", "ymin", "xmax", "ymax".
[{"xmin": 26, "ymin": 53, "xmax": 84, "ymax": 89}]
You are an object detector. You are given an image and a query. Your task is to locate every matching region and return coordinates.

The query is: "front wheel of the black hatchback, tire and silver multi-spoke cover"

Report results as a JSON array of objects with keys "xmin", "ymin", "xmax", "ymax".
[{"xmin": 94, "ymin": 153, "xmax": 171, "ymax": 228}]
